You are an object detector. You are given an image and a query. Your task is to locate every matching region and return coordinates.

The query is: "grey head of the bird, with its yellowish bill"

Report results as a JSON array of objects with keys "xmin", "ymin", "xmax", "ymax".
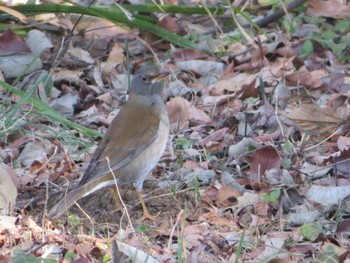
[{"xmin": 130, "ymin": 66, "xmax": 170, "ymax": 96}]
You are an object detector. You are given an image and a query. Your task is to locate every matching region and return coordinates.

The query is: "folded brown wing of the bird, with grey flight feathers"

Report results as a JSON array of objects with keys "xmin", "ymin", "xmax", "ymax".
[{"xmin": 78, "ymin": 100, "xmax": 161, "ymax": 186}]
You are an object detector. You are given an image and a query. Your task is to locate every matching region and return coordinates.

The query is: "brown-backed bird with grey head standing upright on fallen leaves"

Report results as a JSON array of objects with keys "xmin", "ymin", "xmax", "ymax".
[{"xmin": 48, "ymin": 65, "xmax": 170, "ymax": 220}]
